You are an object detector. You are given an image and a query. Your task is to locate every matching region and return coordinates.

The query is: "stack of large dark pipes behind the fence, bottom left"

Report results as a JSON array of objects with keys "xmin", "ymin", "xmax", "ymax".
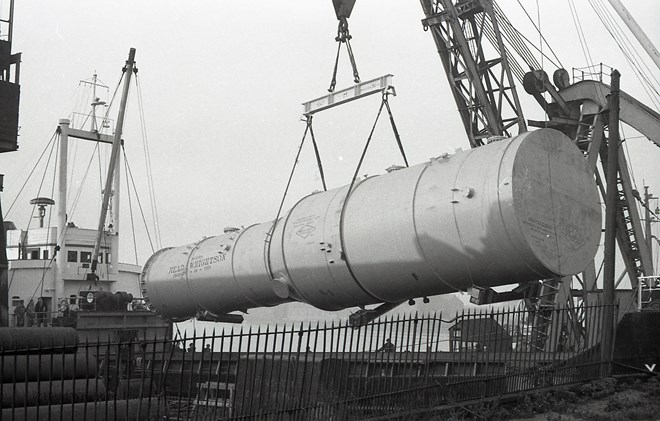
[{"xmin": 0, "ymin": 327, "xmax": 157, "ymax": 420}]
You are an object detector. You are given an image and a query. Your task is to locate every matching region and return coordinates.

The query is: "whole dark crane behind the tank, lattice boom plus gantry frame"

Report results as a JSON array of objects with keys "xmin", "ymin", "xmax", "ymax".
[{"xmin": 420, "ymin": 0, "xmax": 660, "ymax": 347}]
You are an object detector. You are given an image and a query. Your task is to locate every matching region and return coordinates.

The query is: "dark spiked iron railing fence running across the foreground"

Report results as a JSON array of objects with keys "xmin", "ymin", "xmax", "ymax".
[{"xmin": 0, "ymin": 305, "xmax": 617, "ymax": 420}]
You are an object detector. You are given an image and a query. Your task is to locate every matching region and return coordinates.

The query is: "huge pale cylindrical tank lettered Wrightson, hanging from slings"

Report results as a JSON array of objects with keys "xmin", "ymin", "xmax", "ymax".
[{"xmin": 142, "ymin": 129, "xmax": 601, "ymax": 318}]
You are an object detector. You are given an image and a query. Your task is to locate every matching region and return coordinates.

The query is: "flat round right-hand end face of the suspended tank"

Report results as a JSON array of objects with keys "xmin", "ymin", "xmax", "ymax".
[{"xmin": 512, "ymin": 129, "xmax": 601, "ymax": 276}]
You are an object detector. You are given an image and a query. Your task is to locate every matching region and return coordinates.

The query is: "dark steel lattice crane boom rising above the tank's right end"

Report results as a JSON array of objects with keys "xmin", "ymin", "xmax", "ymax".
[{"xmin": 421, "ymin": 0, "xmax": 527, "ymax": 147}]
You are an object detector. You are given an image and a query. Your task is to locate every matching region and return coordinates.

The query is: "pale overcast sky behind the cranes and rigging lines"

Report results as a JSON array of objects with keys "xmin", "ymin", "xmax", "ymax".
[{"xmin": 0, "ymin": 0, "xmax": 660, "ymax": 270}]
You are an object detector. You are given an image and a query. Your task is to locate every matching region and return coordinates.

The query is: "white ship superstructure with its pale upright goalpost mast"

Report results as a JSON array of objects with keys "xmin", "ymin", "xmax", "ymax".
[{"xmin": 5, "ymin": 58, "xmax": 146, "ymax": 326}]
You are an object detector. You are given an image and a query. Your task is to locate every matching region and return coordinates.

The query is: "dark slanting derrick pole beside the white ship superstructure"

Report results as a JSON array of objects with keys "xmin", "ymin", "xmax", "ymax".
[{"xmin": 87, "ymin": 48, "xmax": 135, "ymax": 281}]
